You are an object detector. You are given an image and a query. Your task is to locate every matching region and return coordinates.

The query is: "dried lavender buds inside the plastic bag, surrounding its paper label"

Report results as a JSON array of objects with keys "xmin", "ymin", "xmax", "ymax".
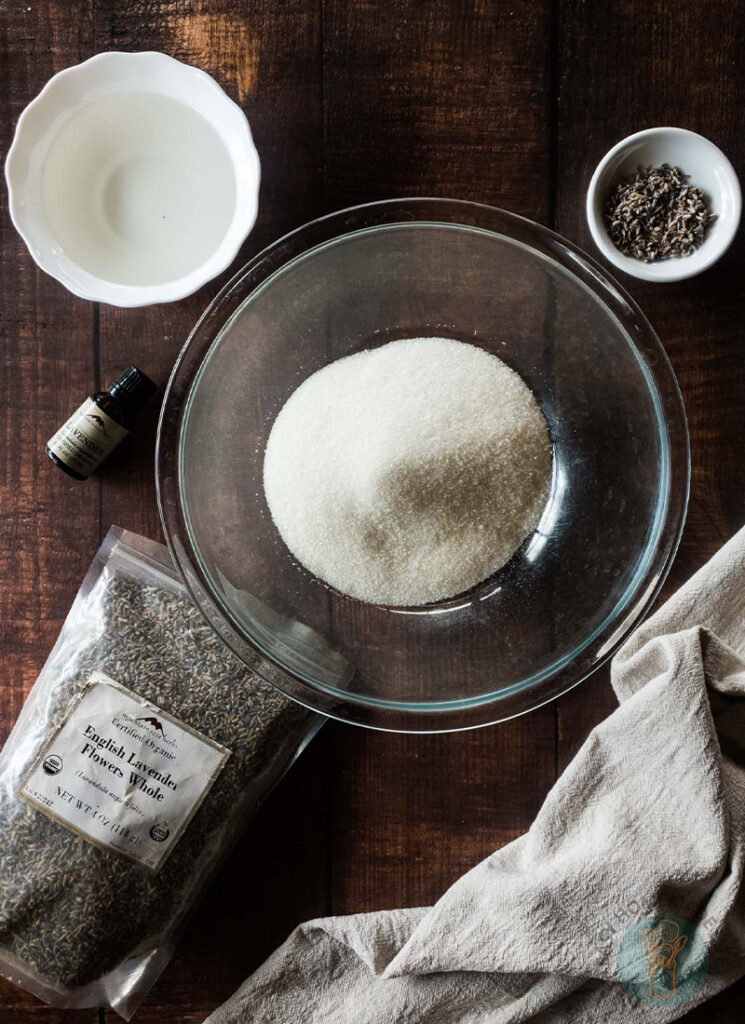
[{"xmin": 0, "ymin": 568, "xmax": 309, "ymax": 989}]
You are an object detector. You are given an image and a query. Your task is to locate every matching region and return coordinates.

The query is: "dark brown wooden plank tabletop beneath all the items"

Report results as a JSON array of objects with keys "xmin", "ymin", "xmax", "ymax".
[{"xmin": 0, "ymin": 0, "xmax": 745, "ymax": 1024}]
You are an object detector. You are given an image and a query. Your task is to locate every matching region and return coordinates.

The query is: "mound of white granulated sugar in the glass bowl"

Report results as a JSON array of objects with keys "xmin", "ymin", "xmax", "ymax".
[{"xmin": 264, "ymin": 338, "xmax": 552, "ymax": 605}]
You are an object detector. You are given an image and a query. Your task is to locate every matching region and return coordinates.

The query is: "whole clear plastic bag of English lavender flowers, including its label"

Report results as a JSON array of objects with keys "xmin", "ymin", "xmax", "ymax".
[{"xmin": 0, "ymin": 527, "xmax": 324, "ymax": 1020}]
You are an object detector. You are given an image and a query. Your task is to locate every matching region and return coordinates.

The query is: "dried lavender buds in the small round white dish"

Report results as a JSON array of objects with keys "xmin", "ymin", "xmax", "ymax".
[{"xmin": 605, "ymin": 164, "xmax": 715, "ymax": 263}]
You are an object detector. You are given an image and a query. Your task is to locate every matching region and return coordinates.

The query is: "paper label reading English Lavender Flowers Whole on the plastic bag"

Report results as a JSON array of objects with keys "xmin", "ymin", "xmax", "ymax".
[{"xmin": 19, "ymin": 672, "xmax": 230, "ymax": 870}]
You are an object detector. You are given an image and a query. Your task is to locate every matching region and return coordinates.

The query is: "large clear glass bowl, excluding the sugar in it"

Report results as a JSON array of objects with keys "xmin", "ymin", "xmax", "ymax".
[{"xmin": 158, "ymin": 200, "xmax": 689, "ymax": 731}]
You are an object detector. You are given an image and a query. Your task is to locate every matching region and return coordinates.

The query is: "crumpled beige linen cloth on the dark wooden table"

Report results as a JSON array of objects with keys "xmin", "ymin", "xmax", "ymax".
[{"xmin": 209, "ymin": 529, "xmax": 745, "ymax": 1024}]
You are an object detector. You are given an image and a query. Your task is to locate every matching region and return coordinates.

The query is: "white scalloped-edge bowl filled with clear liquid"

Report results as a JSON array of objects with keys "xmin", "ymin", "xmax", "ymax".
[{"xmin": 5, "ymin": 52, "xmax": 260, "ymax": 306}]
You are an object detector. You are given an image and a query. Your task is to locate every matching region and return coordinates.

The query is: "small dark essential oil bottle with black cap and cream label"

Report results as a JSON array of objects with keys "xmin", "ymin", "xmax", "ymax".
[{"xmin": 46, "ymin": 367, "xmax": 158, "ymax": 480}]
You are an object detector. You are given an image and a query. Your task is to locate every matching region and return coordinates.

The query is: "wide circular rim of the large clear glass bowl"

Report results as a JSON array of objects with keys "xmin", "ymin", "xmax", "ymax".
[{"xmin": 156, "ymin": 198, "xmax": 691, "ymax": 732}]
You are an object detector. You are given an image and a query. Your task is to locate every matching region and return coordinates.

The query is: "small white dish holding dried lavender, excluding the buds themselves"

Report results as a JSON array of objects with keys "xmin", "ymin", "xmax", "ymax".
[{"xmin": 586, "ymin": 128, "xmax": 742, "ymax": 282}]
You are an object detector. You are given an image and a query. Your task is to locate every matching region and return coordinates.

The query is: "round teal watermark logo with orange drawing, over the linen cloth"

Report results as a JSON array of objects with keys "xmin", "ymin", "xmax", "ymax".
[{"xmin": 616, "ymin": 914, "xmax": 709, "ymax": 1007}]
